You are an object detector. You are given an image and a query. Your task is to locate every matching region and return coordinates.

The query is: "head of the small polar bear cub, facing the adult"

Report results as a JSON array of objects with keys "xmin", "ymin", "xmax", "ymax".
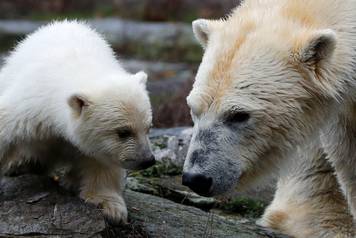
[{"xmin": 68, "ymin": 72, "xmax": 155, "ymax": 169}]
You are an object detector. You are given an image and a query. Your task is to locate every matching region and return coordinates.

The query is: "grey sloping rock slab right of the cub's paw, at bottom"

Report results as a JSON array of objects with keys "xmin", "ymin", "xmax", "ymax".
[{"xmin": 126, "ymin": 190, "xmax": 284, "ymax": 238}]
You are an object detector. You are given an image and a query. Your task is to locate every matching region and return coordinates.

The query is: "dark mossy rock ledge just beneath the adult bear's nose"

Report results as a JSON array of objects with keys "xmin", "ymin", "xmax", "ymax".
[{"xmin": 130, "ymin": 167, "xmax": 267, "ymax": 218}]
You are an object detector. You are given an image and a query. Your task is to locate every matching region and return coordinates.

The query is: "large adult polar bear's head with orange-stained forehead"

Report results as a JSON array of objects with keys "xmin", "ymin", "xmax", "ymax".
[{"xmin": 182, "ymin": 7, "xmax": 337, "ymax": 196}]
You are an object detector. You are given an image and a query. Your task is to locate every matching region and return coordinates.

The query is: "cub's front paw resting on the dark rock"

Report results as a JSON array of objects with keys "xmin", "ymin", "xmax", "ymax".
[{"xmin": 81, "ymin": 194, "xmax": 127, "ymax": 225}]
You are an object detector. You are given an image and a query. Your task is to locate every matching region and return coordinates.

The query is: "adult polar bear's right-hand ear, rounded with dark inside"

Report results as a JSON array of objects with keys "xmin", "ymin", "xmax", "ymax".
[{"xmin": 299, "ymin": 29, "xmax": 337, "ymax": 65}]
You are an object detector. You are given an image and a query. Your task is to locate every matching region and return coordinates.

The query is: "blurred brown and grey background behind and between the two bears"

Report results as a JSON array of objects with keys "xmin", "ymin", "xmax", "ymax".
[{"xmin": 0, "ymin": 0, "xmax": 239, "ymax": 127}]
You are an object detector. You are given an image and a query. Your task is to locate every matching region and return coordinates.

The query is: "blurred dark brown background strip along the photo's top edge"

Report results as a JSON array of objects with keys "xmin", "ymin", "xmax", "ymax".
[{"xmin": 0, "ymin": 0, "xmax": 238, "ymax": 22}]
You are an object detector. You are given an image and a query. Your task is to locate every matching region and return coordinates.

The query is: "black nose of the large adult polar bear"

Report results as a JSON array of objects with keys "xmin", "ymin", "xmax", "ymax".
[{"xmin": 182, "ymin": 173, "xmax": 213, "ymax": 197}]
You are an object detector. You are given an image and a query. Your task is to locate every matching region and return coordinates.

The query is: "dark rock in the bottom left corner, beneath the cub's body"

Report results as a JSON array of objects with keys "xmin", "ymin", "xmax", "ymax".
[{"xmin": 0, "ymin": 175, "xmax": 105, "ymax": 237}]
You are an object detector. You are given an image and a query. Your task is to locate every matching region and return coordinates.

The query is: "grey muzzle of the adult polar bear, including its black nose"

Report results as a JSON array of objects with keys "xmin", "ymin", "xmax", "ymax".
[{"xmin": 183, "ymin": 122, "xmax": 241, "ymax": 196}]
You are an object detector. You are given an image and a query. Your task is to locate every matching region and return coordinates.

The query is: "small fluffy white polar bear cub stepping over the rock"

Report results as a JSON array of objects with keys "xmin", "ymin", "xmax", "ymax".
[{"xmin": 0, "ymin": 21, "xmax": 155, "ymax": 221}]
